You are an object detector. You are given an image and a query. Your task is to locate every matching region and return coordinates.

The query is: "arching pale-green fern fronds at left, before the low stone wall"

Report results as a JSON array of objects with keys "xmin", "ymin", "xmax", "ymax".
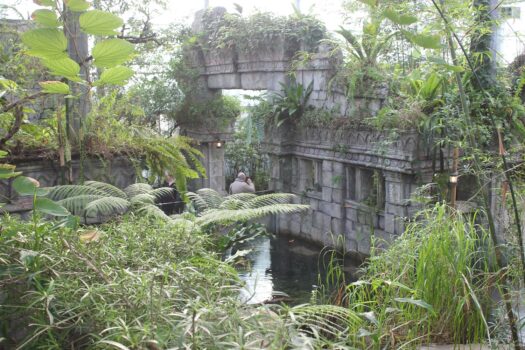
[{"xmin": 47, "ymin": 181, "xmax": 173, "ymax": 222}]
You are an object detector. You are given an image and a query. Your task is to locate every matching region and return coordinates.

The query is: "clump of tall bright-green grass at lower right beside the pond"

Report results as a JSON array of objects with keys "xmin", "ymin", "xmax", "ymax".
[{"xmin": 347, "ymin": 204, "xmax": 495, "ymax": 348}]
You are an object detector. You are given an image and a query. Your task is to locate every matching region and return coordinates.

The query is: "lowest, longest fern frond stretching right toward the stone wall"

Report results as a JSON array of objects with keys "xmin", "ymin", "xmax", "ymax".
[{"xmin": 195, "ymin": 204, "xmax": 309, "ymax": 226}]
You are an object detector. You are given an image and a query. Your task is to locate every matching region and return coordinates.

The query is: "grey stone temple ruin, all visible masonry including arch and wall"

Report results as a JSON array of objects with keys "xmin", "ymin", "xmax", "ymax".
[{"xmin": 182, "ymin": 8, "xmax": 440, "ymax": 254}]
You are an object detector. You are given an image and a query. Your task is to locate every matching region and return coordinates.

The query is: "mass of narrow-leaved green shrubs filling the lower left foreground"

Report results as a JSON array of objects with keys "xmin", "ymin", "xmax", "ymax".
[{"xmin": 0, "ymin": 214, "xmax": 363, "ymax": 349}]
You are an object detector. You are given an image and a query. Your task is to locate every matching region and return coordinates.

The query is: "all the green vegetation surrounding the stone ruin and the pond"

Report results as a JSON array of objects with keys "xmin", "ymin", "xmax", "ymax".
[{"xmin": 0, "ymin": 0, "xmax": 525, "ymax": 349}]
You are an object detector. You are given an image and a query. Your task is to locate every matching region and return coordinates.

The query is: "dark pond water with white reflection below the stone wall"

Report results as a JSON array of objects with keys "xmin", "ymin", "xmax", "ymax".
[{"xmin": 237, "ymin": 235, "xmax": 360, "ymax": 304}]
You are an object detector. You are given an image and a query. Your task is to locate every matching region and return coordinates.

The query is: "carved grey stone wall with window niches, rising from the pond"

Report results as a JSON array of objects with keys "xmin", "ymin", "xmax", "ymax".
[{"xmin": 265, "ymin": 126, "xmax": 432, "ymax": 254}]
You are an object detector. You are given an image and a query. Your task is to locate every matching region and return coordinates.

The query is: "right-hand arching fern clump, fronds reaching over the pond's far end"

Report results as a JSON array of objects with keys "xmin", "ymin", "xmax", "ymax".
[{"xmin": 178, "ymin": 188, "xmax": 308, "ymax": 229}]
